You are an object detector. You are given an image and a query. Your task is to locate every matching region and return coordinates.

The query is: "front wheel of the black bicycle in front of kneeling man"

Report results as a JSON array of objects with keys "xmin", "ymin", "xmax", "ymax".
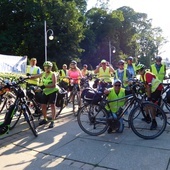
[{"xmin": 129, "ymin": 102, "xmax": 167, "ymax": 139}]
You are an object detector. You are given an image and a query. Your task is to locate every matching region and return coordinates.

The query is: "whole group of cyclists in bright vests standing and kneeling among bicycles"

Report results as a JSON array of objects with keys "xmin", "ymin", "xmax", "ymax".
[{"xmin": 27, "ymin": 56, "xmax": 166, "ymax": 133}]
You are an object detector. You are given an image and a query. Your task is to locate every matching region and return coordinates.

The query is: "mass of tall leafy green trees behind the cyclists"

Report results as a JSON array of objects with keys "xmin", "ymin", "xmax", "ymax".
[{"xmin": 0, "ymin": 0, "xmax": 166, "ymax": 68}]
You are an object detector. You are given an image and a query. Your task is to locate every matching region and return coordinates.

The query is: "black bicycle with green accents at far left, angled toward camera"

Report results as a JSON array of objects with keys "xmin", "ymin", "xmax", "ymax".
[{"xmin": 0, "ymin": 78, "xmax": 38, "ymax": 137}]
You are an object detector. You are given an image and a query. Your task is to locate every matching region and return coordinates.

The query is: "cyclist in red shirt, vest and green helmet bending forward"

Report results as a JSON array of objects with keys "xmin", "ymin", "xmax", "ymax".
[{"xmin": 136, "ymin": 64, "xmax": 163, "ymax": 130}]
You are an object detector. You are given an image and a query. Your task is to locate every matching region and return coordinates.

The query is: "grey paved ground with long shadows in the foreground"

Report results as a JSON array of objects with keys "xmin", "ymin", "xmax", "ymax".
[{"xmin": 0, "ymin": 105, "xmax": 170, "ymax": 170}]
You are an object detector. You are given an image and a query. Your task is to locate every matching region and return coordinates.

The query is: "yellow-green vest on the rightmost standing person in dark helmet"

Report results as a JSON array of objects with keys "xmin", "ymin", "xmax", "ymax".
[{"xmin": 151, "ymin": 64, "xmax": 165, "ymax": 82}]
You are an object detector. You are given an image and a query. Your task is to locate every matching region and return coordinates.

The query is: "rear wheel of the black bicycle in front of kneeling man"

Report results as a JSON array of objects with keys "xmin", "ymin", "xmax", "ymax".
[{"xmin": 77, "ymin": 104, "xmax": 108, "ymax": 136}]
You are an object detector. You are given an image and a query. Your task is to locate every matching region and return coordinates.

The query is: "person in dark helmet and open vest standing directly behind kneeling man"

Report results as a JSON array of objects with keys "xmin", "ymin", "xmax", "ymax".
[{"xmin": 114, "ymin": 60, "xmax": 131, "ymax": 88}]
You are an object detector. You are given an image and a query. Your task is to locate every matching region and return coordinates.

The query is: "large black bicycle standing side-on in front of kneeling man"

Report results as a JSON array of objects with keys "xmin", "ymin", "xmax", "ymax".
[{"xmin": 77, "ymin": 83, "xmax": 167, "ymax": 139}]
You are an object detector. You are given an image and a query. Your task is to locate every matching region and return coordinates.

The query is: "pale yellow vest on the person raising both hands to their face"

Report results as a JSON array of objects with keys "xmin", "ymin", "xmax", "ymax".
[{"xmin": 98, "ymin": 67, "xmax": 112, "ymax": 82}]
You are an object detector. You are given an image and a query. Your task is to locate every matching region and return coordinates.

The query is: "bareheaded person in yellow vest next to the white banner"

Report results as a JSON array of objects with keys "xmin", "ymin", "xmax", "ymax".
[{"xmin": 26, "ymin": 58, "xmax": 41, "ymax": 87}]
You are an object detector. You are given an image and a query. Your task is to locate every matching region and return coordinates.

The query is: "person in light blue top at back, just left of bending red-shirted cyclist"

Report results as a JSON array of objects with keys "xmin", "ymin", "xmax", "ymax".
[{"xmin": 124, "ymin": 56, "xmax": 136, "ymax": 78}]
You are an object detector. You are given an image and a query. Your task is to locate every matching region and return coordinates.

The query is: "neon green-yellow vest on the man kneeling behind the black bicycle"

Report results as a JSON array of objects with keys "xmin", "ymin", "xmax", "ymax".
[{"xmin": 106, "ymin": 88, "xmax": 125, "ymax": 113}]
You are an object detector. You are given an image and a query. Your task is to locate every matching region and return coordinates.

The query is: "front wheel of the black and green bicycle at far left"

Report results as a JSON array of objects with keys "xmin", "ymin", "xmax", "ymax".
[{"xmin": 24, "ymin": 105, "xmax": 38, "ymax": 137}]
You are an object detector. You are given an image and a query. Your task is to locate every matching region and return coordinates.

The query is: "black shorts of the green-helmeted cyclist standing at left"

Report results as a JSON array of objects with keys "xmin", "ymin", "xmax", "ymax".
[{"xmin": 41, "ymin": 92, "xmax": 57, "ymax": 104}]
